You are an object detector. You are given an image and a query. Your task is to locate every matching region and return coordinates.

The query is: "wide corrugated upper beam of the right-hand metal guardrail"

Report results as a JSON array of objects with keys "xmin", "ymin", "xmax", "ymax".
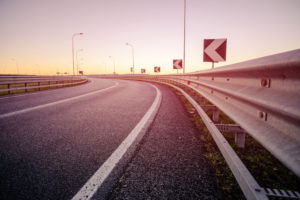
[{"xmin": 164, "ymin": 50, "xmax": 300, "ymax": 177}]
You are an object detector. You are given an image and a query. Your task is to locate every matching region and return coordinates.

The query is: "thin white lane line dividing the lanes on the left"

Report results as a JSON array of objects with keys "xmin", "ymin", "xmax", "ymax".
[{"xmin": 0, "ymin": 82, "xmax": 119, "ymax": 119}]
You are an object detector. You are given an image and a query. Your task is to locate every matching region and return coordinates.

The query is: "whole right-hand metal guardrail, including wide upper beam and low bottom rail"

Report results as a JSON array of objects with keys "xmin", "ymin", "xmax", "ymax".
[{"xmin": 107, "ymin": 49, "xmax": 300, "ymax": 199}]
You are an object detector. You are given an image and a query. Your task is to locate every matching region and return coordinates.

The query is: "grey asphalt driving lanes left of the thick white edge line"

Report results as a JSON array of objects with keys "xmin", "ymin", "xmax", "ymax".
[{"xmin": 0, "ymin": 79, "xmax": 156, "ymax": 199}]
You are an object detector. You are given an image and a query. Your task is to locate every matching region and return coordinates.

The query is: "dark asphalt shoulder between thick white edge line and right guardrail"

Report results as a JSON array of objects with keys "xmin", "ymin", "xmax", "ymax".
[{"xmin": 107, "ymin": 83, "xmax": 222, "ymax": 200}]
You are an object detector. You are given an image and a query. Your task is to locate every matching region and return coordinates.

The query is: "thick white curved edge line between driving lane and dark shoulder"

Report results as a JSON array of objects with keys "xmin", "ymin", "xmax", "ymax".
[{"xmin": 72, "ymin": 84, "xmax": 162, "ymax": 200}]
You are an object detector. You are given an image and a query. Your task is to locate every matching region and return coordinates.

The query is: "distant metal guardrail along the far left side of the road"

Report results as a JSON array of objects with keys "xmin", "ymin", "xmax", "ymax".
[{"xmin": 0, "ymin": 75, "xmax": 87, "ymax": 94}]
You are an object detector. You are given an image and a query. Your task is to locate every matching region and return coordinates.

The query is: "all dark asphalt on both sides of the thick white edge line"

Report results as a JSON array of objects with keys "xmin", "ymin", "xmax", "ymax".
[{"xmin": 0, "ymin": 79, "xmax": 220, "ymax": 200}]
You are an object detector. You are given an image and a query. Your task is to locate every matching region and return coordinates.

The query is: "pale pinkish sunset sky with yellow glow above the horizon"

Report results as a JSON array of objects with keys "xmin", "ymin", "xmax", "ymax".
[{"xmin": 0, "ymin": 0, "xmax": 300, "ymax": 75}]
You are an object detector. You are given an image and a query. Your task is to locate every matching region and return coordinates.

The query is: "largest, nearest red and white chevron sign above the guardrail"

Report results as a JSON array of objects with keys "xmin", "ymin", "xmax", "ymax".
[{"xmin": 203, "ymin": 39, "xmax": 227, "ymax": 62}]
